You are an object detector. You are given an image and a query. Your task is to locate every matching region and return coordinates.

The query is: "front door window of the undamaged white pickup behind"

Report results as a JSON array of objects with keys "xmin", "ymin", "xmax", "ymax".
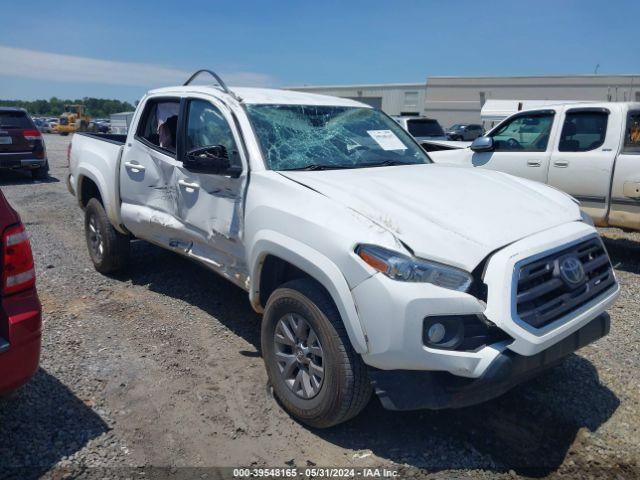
[{"xmin": 491, "ymin": 113, "xmax": 554, "ymax": 152}]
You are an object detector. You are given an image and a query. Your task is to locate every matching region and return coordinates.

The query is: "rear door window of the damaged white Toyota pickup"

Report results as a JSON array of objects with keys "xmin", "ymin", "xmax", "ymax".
[{"xmin": 136, "ymin": 99, "xmax": 180, "ymax": 154}]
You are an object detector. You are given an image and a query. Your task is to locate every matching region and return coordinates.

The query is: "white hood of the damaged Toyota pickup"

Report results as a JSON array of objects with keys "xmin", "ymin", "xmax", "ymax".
[{"xmin": 280, "ymin": 164, "xmax": 581, "ymax": 271}]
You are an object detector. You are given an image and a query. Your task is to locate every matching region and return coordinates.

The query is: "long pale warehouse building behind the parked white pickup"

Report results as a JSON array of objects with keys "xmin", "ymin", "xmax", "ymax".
[{"xmin": 291, "ymin": 74, "xmax": 640, "ymax": 127}]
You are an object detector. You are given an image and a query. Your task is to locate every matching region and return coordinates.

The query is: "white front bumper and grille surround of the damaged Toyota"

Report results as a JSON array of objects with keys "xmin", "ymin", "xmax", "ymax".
[{"xmin": 352, "ymin": 222, "xmax": 619, "ymax": 378}]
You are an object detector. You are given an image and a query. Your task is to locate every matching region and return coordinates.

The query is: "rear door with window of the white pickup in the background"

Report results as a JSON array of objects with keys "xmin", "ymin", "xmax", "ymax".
[{"xmin": 549, "ymin": 107, "xmax": 622, "ymax": 223}]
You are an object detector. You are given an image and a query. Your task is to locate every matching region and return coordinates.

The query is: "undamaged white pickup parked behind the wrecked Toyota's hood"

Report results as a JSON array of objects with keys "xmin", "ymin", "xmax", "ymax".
[{"xmin": 430, "ymin": 102, "xmax": 640, "ymax": 230}]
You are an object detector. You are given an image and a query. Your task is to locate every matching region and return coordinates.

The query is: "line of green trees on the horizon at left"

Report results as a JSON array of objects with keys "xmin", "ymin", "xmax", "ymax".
[{"xmin": 0, "ymin": 97, "xmax": 138, "ymax": 118}]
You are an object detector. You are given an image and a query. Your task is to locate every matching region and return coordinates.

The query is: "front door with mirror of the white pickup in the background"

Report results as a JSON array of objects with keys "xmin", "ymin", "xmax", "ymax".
[{"xmin": 471, "ymin": 110, "xmax": 557, "ymax": 183}]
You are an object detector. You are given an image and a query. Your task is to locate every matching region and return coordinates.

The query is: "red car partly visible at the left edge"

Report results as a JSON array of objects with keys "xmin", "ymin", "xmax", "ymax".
[{"xmin": 0, "ymin": 191, "xmax": 42, "ymax": 395}]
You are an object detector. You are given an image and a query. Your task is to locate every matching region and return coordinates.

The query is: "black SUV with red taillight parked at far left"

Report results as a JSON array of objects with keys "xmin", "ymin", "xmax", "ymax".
[{"xmin": 0, "ymin": 107, "xmax": 49, "ymax": 179}]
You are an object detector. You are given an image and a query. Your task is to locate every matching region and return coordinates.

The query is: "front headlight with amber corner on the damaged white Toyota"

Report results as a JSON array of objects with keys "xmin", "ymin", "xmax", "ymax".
[{"xmin": 356, "ymin": 245, "xmax": 473, "ymax": 292}]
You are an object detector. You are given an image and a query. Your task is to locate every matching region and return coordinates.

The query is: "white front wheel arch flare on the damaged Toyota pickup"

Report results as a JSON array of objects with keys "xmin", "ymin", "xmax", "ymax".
[{"xmin": 249, "ymin": 231, "xmax": 368, "ymax": 353}]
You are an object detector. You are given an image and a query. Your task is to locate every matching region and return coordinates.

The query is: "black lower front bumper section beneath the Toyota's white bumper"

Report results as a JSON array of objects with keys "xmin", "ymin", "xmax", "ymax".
[{"xmin": 369, "ymin": 313, "xmax": 610, "ymax": 410}]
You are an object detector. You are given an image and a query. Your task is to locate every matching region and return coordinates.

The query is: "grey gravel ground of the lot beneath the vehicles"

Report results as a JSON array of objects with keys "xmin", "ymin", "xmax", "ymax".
[{"xmin": 0, "ymin": 135, "xmax": 640, "ymax": 478}]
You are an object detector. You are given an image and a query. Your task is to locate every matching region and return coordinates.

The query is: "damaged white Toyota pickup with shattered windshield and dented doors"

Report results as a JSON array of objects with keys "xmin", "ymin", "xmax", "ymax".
[{"xmin": 68, "ymin": 72, "xmax": 619, "ymax": 427}]
